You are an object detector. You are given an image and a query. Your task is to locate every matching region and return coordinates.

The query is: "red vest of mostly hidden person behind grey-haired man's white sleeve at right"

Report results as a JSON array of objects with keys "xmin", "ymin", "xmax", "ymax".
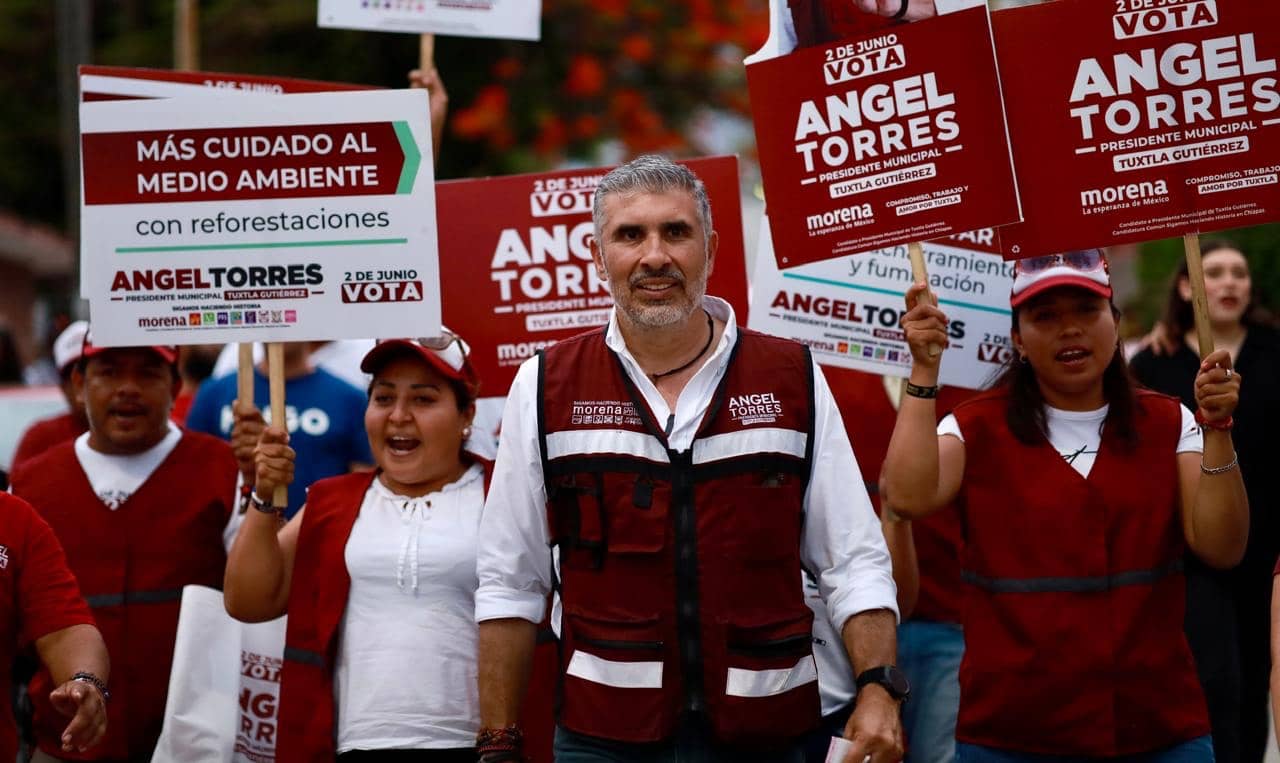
[{"xmin": 823, "ymin": 366, "xmax": 977, "ymax": 622}]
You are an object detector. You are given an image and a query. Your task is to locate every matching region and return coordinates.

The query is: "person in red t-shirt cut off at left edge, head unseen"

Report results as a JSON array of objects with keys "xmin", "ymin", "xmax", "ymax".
[{"xmin": 0, "ymin": 493, "xmax": 110, "ymax": 760}]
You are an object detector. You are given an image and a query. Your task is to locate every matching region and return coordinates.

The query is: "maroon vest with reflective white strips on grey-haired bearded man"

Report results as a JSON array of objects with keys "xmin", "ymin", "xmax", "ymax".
[{"xmin": 538, "ymin": 329, "xmax": 820, "ymax": 745}]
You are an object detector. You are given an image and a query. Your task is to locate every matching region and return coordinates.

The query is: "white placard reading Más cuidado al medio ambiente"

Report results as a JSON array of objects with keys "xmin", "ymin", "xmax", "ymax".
[{"xmin": 81, "ymin": 90, "xmax": 440, "ymax": 344}]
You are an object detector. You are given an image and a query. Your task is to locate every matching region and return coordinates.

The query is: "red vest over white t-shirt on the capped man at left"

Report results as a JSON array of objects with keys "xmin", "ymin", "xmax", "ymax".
[{"xmin": 13, "ymin": 431, "xmax": 237, "ymax": 760}]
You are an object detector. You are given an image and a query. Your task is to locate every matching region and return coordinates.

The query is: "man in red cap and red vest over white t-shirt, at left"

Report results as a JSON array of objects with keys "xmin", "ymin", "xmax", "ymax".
[{"xmin": 13, "ymin": 334, "xmax": 237, "ymax": 762}]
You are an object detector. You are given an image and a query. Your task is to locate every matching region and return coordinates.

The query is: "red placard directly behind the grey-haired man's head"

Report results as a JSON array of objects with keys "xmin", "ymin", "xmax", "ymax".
[{"xmin": 435, "ymin": 156, "xmax": 746, "ymax": 397}]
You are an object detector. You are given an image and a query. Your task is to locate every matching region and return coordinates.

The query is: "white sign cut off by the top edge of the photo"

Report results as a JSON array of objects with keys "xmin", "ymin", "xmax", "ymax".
[{"xmin": 316, "ymin": 0, "xmax": 543, "ymax": 40}]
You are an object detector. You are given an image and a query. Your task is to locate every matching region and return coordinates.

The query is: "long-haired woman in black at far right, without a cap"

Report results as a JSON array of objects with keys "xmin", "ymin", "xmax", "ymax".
[{"xmin": 1130, "ymin": 239, "xmax": 1280, "ymax": 763}]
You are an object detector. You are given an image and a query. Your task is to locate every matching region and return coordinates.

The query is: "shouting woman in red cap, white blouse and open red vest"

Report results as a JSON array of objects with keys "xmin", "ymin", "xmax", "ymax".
[{"xmin": 225, "ymin": 333, "xmax": 486, "ymax": 763}]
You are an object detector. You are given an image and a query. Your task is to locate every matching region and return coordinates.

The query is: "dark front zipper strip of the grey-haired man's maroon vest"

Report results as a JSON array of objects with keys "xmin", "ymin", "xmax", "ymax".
[{"xmin": 667, "ymin": 449, "xmax": 707, "ymax": 713}]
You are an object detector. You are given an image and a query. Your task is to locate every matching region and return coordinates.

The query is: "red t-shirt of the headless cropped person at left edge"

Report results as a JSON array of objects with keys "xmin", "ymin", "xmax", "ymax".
[{"xmin": 0, "ymin": 493, "xmax": 93, "ymax": 760}]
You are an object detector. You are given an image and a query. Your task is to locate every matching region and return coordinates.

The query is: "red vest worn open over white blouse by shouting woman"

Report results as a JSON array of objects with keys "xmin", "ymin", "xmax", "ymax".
[{"xmin": 275, "ymin": 461, "xmax": 556, "ymax": 763}]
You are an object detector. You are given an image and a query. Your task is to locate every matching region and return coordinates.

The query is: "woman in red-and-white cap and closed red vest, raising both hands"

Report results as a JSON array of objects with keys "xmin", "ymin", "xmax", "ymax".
[{"xmin": 884, "ymin": 250, "xmax": 1248, "ymax": 763}]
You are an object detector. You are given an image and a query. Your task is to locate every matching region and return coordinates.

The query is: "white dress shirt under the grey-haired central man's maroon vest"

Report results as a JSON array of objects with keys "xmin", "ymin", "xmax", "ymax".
[{"xmin": 476, "ymin": 297, "xmax": 897, "ymax": 637}]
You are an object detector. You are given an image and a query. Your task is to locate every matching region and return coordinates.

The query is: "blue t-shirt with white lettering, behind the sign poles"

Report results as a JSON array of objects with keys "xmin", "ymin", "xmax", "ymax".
[{"xmin": 187, "ymin": 369, "xmax": 374, "ymax": 517}]
